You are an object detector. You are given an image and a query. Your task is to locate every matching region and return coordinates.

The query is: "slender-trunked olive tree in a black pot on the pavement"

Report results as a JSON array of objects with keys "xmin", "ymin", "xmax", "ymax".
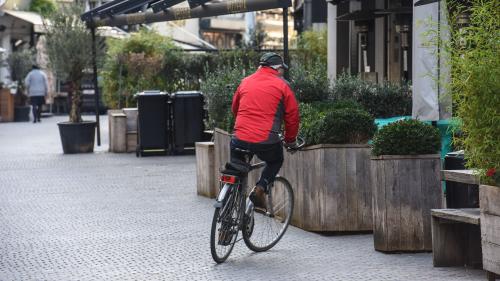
[{"xmin": 45, "ymin": 4, "xmax": 102, "ymax": 153}]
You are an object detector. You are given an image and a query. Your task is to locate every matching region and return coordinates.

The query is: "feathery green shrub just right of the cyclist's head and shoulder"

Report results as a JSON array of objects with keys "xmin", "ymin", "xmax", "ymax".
[{"xmin": 290, "ymin": 60, "xmax": 330, "ymax": 103}]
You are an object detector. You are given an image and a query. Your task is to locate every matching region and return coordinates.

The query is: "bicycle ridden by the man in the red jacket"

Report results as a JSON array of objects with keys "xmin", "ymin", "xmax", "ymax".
[{"xmin": 210, "ymin": 135, "xmax": 305, "ymax": 263}]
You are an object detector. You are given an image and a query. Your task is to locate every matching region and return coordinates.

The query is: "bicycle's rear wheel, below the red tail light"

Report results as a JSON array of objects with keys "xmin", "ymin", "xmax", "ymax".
[{"xmin": 210, "ymin": 185, "xmax": 242, "ymax": 263}]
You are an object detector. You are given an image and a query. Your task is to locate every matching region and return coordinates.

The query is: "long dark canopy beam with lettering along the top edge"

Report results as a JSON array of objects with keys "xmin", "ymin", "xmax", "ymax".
[{"xmin": 82, "ymin": 0, "xmax": 292, "ymax": 27}]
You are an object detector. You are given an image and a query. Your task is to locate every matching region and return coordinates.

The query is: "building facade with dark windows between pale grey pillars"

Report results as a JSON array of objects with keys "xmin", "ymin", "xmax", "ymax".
[{"xmin": 327, "ymin": 0, "xmax": 451, "ymax": 121}]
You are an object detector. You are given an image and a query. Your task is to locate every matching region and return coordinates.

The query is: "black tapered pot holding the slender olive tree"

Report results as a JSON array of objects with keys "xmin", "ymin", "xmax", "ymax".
[{"xmin": 57, "ymin": 121, "xmax": 96, "ymax": 154}]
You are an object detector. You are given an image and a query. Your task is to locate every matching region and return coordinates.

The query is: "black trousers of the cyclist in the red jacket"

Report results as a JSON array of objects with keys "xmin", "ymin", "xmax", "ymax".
[{"xmin": 231, "ymin": 137, "xmax": 283, "ymax": 190}]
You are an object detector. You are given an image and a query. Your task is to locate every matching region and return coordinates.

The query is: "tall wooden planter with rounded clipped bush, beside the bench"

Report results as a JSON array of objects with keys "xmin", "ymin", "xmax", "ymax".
[{"xmin": 372, "ymin": 120, "xmax": 442, "ymax": 252}]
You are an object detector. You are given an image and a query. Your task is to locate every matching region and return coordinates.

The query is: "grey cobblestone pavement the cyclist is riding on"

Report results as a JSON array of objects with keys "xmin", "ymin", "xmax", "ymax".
[{"xmin": 0, "ymin": 116, "xmax": 485, "ymax": 281}]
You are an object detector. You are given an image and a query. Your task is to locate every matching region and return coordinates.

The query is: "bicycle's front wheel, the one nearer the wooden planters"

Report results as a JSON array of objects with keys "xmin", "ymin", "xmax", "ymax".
[{"xmin": 242, "ymin": 176, "xmax": 293, "ymax": 252}]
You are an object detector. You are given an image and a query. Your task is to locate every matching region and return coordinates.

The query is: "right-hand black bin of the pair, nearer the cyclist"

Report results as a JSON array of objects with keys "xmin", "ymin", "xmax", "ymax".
[{"xmin": 170, "ymin": 91, "xmax": 206, "ymax": 153}]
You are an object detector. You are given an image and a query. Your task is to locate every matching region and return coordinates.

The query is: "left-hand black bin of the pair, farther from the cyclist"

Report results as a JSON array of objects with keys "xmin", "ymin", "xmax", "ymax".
[{"xmin": 136, "ymin": 91, "xmax": 170, "ymax": 157}]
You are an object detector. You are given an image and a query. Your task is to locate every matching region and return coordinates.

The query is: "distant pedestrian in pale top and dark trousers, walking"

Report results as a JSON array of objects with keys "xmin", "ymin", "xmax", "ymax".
[{"xmin": 24, "ymin": 65, "xmax": 49, "ymax": 123}]
